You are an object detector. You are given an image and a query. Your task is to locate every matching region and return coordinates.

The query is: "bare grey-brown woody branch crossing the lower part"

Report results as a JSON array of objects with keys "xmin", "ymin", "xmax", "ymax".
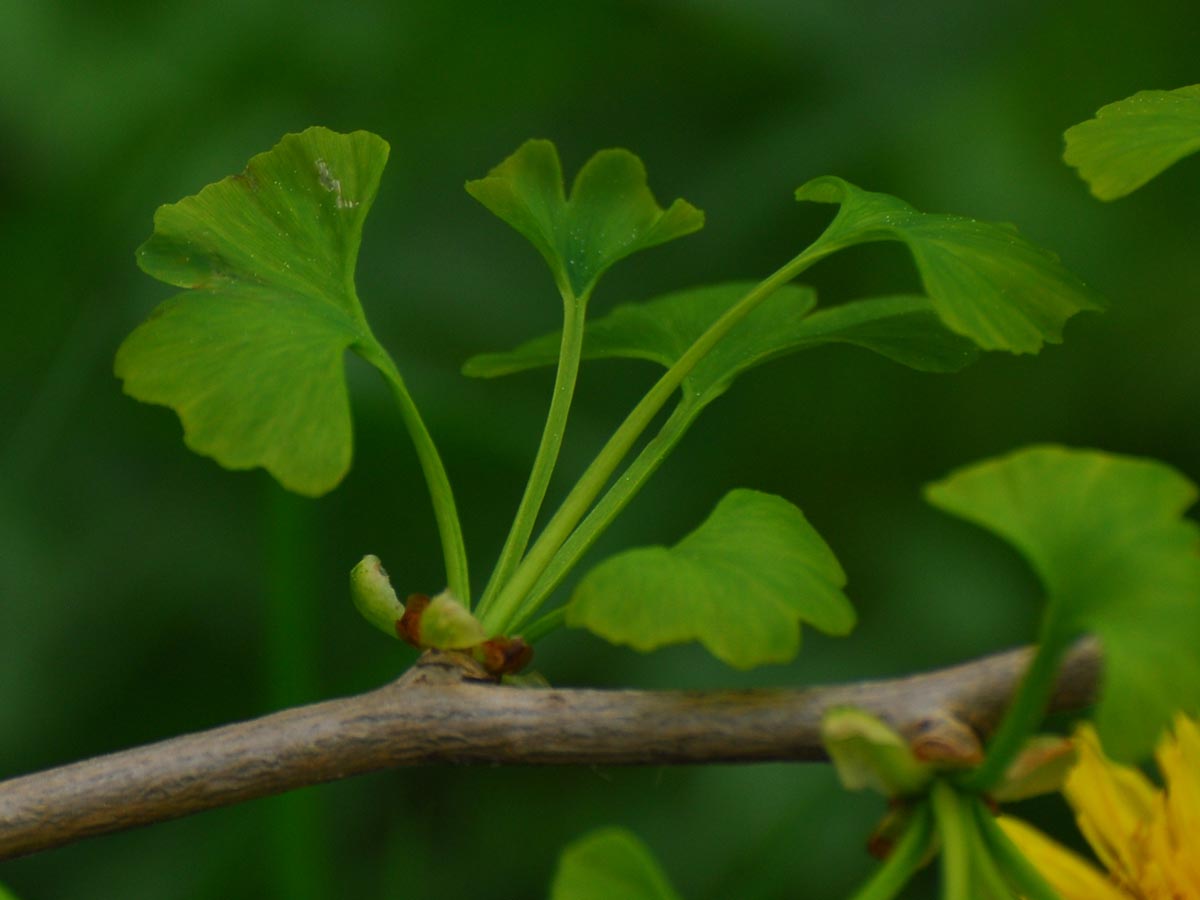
[{"xmin": 0, "ymin": 642, "xmax": 1100, "ymax": 859}]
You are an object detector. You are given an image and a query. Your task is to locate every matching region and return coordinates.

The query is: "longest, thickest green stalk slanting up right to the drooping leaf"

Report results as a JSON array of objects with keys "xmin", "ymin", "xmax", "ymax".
[{"xmin": 480, "ymin": 240, "xmax": 833, "ymax": 634}]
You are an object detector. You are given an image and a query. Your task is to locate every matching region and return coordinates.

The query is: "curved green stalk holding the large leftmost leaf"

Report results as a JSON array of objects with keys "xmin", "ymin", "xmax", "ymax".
[{"xmin": 359, "ymin": 337, "xmax": 470, "ymax": 610}]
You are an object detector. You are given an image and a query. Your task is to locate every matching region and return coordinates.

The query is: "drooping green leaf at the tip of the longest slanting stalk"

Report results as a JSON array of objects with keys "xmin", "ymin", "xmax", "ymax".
[{"xmin": 796, "ymin": 176, "xmax": 1099, "ymax": 353}]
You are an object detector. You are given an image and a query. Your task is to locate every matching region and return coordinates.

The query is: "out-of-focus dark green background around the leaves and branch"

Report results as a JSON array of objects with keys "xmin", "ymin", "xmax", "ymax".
[{"xmin": 0, "ymin": 0, "xmax": 1200, "ymax": 900}]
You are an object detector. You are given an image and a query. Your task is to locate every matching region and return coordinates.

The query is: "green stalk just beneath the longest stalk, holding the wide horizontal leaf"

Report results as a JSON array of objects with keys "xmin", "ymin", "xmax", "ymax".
[{"xmin": 512, "ymin": 401, "xmax": 701, "ymax": 640}]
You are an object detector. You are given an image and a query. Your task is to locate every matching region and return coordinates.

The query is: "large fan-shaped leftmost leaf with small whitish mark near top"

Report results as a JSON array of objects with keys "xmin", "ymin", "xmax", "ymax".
[{"xmin": 115, "ymin": 128, "xmax": 388, "ymax": 496}]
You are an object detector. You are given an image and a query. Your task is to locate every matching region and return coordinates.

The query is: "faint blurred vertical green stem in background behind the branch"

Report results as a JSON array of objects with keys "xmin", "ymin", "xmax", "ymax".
[{"xmin": 263, "ymin": 481, "xmax": 334, "ymax": 900}]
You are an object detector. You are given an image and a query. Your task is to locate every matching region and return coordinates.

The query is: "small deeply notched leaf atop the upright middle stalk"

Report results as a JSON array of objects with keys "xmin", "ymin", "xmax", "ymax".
[{"xmin": 467, "ymin": 140, "xmax": 704, "ymax": 298}]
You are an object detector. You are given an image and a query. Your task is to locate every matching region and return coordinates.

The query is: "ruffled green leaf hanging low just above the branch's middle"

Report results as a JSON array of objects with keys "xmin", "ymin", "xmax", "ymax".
[{"xmin": 566, "ymin": 490, "xmax": 854, "ymax": 668}]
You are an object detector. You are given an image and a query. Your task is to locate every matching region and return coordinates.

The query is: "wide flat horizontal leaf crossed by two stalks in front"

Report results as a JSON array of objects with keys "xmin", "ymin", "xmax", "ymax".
[{"xmin": 462, "ymin": 282, "xmax": 978, "ymax": 404}]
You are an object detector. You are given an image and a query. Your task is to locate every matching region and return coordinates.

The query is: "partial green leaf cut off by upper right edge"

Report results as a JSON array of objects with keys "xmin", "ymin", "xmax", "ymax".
[{"xmin": 1062, "ymin": 84, "xmax": 1200, "ymax": 200}]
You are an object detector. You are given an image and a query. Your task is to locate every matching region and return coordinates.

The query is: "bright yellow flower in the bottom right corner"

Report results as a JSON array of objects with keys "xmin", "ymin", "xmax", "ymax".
[{"xmin": 1000, "ymin": 715, "xmax": 1200, "ymax": 900}]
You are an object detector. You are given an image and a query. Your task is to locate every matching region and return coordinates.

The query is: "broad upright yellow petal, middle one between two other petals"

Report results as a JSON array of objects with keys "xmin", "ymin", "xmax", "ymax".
[{"xmin": 1063, "ymin": 725, "xmax": 1158, "ymax": 884}]
